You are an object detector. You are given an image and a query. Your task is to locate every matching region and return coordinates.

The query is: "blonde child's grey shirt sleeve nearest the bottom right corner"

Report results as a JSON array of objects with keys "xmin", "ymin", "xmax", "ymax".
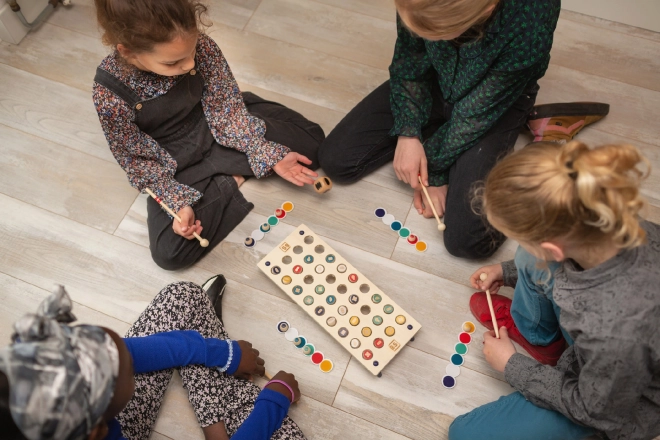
[{"xmin": 504, "ymin": 336, "xmax": 652, "ymax": 438}]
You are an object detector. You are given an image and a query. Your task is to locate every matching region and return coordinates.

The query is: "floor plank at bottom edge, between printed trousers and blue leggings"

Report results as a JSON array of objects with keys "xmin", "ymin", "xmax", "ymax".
[{"xmin": 333, "ymin": 347, "xmax": 513, "ymax": 439}]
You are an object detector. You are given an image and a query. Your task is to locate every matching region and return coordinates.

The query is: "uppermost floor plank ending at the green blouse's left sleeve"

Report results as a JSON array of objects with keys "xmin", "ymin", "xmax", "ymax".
[{"xmin": 245, "ymin": 0, "xmax": 396, "ymax": 69}]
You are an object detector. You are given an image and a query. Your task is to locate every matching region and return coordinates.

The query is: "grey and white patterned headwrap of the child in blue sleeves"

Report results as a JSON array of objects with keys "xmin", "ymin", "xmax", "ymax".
[{"xmin": 0, "ymin": 286, "xmax": 119, "ymax": 440}]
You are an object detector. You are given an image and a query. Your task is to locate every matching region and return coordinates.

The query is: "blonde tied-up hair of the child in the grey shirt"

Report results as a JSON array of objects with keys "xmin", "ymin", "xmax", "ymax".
[{"xmin": 482, "ymin": 141, "xmax": 650, "ymax": 249}]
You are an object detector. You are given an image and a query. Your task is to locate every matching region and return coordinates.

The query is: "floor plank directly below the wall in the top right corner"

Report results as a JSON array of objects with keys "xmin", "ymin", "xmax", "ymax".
[{"xmin": 551, "ymin": 20, "xmax": 660, "ymax": 92}]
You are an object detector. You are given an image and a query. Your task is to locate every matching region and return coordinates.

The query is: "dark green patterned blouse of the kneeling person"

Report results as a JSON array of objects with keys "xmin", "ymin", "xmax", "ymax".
[{"xmin": 390, "ymin": 0, "xmax": 560, "ymax": 186}]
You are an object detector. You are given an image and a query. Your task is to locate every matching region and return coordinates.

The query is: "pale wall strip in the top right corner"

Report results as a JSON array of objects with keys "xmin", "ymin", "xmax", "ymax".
[{"xmin": 561, "ymin": 0, "xmax": 660, "ymax": 32}]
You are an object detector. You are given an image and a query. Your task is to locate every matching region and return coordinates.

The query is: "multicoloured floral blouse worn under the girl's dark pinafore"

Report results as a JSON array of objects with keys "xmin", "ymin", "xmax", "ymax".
[{"xmin": 93, "ymin": 35, "xmax": 290, "ymax": 212}]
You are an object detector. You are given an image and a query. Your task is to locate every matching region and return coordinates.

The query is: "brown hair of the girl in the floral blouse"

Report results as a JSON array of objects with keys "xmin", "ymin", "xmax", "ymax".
[{"xmin": 94, "ymin": 0, "xmax": 207, "ymax": 53}]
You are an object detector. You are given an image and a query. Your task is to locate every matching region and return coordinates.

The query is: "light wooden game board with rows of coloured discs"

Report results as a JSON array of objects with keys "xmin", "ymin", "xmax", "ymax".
[{"xmin": 258, "ymin": 225, "xmax": 422, "ymax": 375}]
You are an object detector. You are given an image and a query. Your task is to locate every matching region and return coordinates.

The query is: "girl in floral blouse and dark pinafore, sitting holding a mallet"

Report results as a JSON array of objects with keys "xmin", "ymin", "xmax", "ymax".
[{"xmin": 93, "ymin": 0, "xmax": 324, "ymax": 270}]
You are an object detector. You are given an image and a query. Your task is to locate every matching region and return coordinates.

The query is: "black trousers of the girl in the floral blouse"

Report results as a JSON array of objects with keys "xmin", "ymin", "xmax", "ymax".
[{"xmin": 147, "ymin": 92, "xmax": 325, "ymax": 270}]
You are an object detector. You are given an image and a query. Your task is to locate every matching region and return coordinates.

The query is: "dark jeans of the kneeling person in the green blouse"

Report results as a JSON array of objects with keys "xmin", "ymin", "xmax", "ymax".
[{"xmin": 319, "ymin": 81, "xmax": 539, "ymax": 259}]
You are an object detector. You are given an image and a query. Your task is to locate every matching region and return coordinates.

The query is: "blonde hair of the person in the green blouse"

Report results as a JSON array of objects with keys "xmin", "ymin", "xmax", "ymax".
[{"xmin": 394, "ymin": 0, "xmax": 499, "ymax": 40}]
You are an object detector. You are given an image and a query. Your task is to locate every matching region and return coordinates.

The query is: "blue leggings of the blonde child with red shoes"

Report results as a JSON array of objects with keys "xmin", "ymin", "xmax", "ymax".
[{"xmin": 449, "ymin": 247, "xmax": 596, "ymax": 440}]
